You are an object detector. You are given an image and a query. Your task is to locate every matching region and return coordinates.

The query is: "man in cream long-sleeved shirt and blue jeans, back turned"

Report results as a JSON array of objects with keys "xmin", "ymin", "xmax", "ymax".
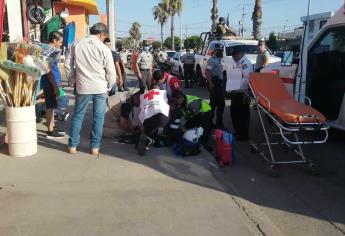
[{"xmin": 65, "ymin": 23, "xmax": 116, "ymax": 155}]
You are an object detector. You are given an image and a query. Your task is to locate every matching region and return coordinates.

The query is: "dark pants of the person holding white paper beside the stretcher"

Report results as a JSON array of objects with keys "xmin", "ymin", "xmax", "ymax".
[{"xmin": 230, "ymin": 92, "xmax": 250, "ymax": 139}]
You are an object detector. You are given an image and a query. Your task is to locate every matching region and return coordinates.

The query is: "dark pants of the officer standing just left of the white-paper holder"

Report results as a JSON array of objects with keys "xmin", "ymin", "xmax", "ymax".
[{"xmin": 210, "ymin": 78, "xmax": 225, "ymax": 127}]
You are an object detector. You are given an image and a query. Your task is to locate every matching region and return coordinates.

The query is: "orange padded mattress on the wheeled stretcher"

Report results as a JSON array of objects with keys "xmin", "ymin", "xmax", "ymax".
[{"xmin": 249, "ymin": 73, "xmax": 326, "ymax": 124}]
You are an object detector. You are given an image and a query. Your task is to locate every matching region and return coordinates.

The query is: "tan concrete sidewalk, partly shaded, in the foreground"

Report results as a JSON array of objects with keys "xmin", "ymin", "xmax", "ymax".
[{"xmin": 0, "ymin": 85, "xmax": 261, "ymax": 236}]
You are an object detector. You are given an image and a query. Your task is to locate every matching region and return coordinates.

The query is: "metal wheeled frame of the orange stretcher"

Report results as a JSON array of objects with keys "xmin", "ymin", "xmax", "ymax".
[{"xmin": 249, "ymin": 83, "xmax": 329, "ymax": 177}]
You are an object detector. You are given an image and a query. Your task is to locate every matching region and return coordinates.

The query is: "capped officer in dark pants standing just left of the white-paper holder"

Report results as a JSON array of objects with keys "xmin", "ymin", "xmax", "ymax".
[{"xmin": 206, "ymin": 44, "xmax": 226, "ymax": 129}]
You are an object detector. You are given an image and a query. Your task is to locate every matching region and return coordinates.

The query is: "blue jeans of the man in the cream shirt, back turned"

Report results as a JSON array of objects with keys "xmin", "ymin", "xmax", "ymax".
[{"xmin": 68, "ymin": 94, "xmax": 107, "ymax": 149}]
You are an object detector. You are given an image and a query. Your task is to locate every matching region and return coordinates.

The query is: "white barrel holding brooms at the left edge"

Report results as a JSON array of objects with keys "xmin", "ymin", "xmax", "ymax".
[{"xmin": 6, "ymin": 106, "xmax": 37, "ymax": 157}]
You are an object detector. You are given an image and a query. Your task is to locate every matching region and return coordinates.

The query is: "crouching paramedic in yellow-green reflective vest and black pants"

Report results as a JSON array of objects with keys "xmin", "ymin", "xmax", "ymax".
[{"xmin": 172, "ymin": 91, "xmax": 213, "ymax": 152}]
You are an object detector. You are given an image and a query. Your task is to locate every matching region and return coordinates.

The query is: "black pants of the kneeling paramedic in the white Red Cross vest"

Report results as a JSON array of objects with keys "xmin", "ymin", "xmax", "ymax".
[{"xmin": 143, "ymin": 113, "xmax": 169, "ymax": 140}]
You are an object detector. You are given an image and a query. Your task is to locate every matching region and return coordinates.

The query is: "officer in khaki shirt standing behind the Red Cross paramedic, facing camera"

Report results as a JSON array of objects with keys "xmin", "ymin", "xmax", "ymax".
[{"xmin": 136, "ymin": 45, "xmax": 153, "ymax": 93}]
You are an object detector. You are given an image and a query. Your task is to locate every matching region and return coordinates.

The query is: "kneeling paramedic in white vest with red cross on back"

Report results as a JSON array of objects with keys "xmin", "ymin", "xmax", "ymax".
[{"xmin": 138, "ymin": 84, "xmax": 170, "ymax": 156}]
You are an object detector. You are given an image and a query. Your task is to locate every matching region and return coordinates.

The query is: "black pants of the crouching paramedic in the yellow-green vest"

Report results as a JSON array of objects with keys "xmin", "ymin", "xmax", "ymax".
[{"xmin": 185, "ymin": 111, "xmax": 213, "ymax": 145}]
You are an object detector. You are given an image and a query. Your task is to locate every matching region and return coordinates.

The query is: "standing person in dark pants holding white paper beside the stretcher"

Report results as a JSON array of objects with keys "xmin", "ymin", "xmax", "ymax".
[{"xmin": 230, "ymin": 46, "xmax": 253, "ymax": 141}]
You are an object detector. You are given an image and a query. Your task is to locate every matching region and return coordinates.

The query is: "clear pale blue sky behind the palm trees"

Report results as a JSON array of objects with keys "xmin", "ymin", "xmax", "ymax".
[{"xmin": 90, "ymin": 0, "xmax": 345, "ymax": 39}]
